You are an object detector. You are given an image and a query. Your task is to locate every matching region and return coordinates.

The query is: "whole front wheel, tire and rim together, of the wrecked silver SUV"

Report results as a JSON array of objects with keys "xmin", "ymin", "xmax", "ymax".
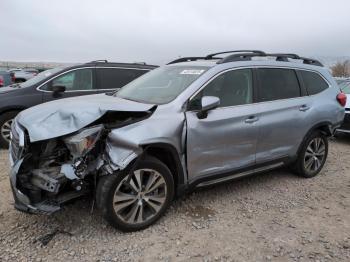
[{"xmin": 96, "ymin": 157, "xmax": 174, "ymax": 232}]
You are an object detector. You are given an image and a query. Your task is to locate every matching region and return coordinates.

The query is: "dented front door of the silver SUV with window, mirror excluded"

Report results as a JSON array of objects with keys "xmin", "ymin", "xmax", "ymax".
[{"xmin": 186, "ymin": 69, "xmax": 259, "ymax": 180}]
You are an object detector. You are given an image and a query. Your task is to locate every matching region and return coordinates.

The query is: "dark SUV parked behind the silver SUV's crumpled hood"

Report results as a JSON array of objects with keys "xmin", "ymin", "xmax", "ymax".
[{"xmin": 0, "ymin": 60, "xmax": 157, "ymax": 147}]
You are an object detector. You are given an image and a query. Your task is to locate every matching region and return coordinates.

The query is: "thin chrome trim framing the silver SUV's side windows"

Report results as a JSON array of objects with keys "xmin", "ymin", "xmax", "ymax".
[{"xmin": 187, "ymin": 65, "xmax": 332, "ymax": 112}]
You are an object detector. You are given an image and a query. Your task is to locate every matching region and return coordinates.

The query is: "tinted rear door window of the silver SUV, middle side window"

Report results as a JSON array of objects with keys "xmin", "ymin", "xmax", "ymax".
[{"xmin": 257, "ymin": 68, "xmax": 300, "ymax": 102}]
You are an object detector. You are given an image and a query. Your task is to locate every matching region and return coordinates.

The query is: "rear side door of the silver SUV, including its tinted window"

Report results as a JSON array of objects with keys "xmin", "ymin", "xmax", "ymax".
[{"xmin": 256, "ymin": 68, "xmax": 311, "ymax": 164}]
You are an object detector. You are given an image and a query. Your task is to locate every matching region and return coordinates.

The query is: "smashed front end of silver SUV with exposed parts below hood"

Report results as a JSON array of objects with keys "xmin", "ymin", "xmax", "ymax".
[{"xmin": 10, "ymin": 111, "xmax": 151, "ymax": 214}]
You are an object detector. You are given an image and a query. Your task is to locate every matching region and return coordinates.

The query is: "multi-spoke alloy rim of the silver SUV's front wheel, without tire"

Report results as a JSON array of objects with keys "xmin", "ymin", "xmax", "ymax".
[{"xmin": 113, "ymin": 169, "xmax": 167, "ymax": 224}]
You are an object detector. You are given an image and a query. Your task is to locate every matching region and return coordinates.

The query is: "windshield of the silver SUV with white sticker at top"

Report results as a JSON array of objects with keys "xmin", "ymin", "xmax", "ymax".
[{"xmin": 115, "ymin": 66, "xmax": 209, "ymax": 104}]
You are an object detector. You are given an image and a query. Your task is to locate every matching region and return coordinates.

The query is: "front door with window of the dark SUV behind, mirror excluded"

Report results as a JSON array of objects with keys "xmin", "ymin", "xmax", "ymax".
[{"xmin": 40, "ymin": 67, "xmax": 98, "ymax": 102}]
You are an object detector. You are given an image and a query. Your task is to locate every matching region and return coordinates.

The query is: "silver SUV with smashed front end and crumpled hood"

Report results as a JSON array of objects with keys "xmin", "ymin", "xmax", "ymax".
[{"xmin": 10, "ymin": 51, "xmax": 346, "ymax": 231}]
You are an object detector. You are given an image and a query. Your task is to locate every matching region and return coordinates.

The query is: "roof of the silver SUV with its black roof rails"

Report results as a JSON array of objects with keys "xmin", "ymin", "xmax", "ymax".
[{"xmin": 168, "ymin": 50, "xmax": 323, "ymax": 69}]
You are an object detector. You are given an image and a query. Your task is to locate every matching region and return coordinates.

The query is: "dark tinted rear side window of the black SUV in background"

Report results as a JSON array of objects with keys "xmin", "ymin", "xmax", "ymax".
[{"xmin": 96, "ymin": 68, "xmax": 149, "ymax": 89}]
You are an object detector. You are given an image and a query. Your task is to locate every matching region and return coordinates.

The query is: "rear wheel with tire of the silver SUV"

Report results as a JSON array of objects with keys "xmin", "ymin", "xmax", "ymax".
[{"xmin": 294, "ymin": 131, "xmax": 328, "ymax": 178}]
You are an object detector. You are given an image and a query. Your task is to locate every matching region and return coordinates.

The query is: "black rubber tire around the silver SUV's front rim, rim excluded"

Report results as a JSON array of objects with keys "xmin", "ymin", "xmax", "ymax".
[{"xmin": 96, "ymin": 157, "xmax": 174, "ymax": 232}]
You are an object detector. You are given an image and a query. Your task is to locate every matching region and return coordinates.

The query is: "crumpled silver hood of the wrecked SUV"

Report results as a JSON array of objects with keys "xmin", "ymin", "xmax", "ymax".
[{"xmin": 16, "ymin": 94, "xmax": 154, "ymax": 142}]
